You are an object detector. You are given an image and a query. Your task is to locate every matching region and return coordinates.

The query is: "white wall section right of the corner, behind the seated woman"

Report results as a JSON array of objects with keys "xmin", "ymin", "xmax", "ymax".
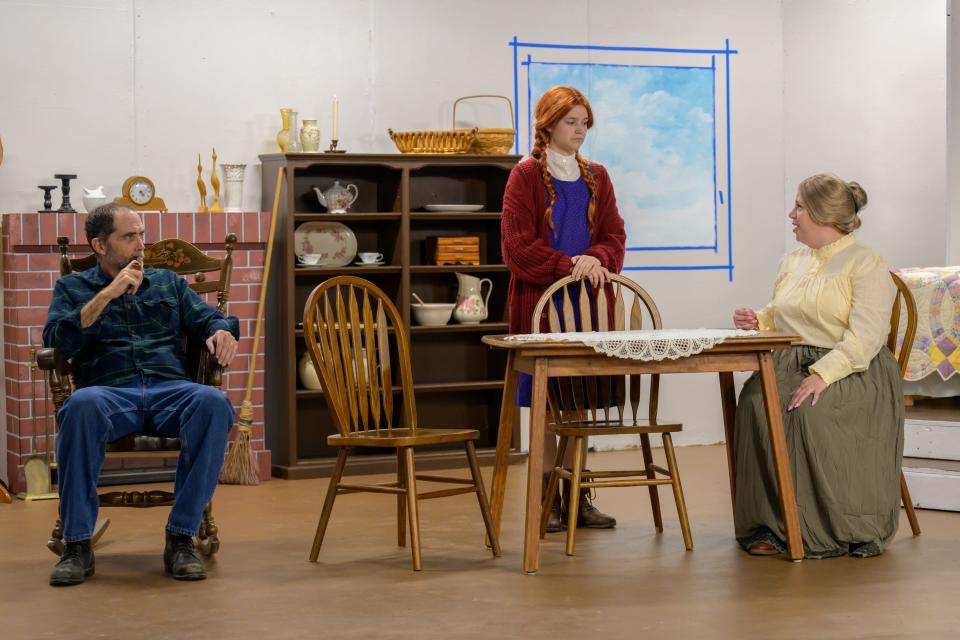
[{"xmin": 783, "ymin": 0, "xmax": 948, "ymax": 268}]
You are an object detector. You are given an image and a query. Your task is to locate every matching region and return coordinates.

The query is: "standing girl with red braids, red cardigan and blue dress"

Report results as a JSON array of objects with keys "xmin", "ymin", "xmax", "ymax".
[{"xmin": 501, "ymin": 86, "xmax": 626, "ymax": 532}]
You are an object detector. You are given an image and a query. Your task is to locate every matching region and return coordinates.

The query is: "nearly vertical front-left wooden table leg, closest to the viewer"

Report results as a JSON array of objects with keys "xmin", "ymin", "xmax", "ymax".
[{"xmin": 523, "ymin": 358, "xmax": 547, "ymax": 573}]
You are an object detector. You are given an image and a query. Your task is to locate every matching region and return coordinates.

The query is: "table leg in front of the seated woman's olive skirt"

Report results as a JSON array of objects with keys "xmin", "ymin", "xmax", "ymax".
[{"xmin": 758, "ymin": 351, "xmax": 803, "ymax": 561}]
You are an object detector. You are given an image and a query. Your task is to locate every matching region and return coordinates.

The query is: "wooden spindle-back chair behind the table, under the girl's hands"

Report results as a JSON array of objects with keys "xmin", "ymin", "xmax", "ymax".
[{"xmin": 532, "ymin": 274, "xmax": 693, "ymax": 556}]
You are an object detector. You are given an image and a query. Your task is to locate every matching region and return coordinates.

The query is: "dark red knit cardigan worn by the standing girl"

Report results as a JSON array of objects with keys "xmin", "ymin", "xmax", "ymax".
[{"xmin": 500, "ymin": 157, "xmax": 627, "ymax": 333}]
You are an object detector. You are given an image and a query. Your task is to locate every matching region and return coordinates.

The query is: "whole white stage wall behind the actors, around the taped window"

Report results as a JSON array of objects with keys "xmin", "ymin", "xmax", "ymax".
[{"xmin": 0, "ymin": 0, "xmax": 946, "ymax": 450}]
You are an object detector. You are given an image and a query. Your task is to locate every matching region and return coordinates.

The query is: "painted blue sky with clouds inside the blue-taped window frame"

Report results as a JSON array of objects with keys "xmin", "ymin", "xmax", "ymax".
[{"xmin": 528, "ymin": 62, "xmax": 717, "ymax": 250}]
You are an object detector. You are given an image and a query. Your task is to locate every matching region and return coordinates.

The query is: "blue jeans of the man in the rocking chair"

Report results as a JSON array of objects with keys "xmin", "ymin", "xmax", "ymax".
[{"xmin": 57, "ymin": 376, "xmax": 234, "ymax": 542}]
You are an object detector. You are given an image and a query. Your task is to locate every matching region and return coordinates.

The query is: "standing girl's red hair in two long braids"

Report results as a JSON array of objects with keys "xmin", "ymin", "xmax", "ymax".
[{"xmin": 530, "ymin": 85, "xmax": 597, "ymax": 233}]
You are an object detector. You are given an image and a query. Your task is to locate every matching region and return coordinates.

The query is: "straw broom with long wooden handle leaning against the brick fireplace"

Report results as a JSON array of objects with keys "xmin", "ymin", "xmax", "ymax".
[{"xmin": 220, "ymin": 167, "xmax": 283, "ymax": 485}]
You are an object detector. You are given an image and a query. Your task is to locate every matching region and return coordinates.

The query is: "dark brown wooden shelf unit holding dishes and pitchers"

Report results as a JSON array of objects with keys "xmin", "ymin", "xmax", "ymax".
[{"xmin": 260, "ymin": 153, "xmax": 520, "ymax": 478}]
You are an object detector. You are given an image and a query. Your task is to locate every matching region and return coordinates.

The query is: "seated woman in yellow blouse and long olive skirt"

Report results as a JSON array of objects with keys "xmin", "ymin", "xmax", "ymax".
[{"xmin": 733, "ymin": 174, "xmax": 904, "ymax": 558}]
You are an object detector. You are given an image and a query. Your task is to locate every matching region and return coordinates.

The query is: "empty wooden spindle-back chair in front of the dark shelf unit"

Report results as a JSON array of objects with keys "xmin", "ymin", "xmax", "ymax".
[{"xmin": 303, "ymin": 276, "xmax": 500, "ymax": 571}]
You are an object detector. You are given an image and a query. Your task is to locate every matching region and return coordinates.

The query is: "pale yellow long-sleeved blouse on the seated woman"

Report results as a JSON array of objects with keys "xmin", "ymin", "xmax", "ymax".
[{"xmin": 757, "ymin": 234, "xmax": 897, "ymax": 384}]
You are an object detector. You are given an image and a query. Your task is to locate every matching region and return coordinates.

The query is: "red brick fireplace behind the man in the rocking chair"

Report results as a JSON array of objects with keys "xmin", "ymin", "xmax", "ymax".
[{"xmin": 0, "ymin": 212, "xmax": 271, "ymax": 492}]
